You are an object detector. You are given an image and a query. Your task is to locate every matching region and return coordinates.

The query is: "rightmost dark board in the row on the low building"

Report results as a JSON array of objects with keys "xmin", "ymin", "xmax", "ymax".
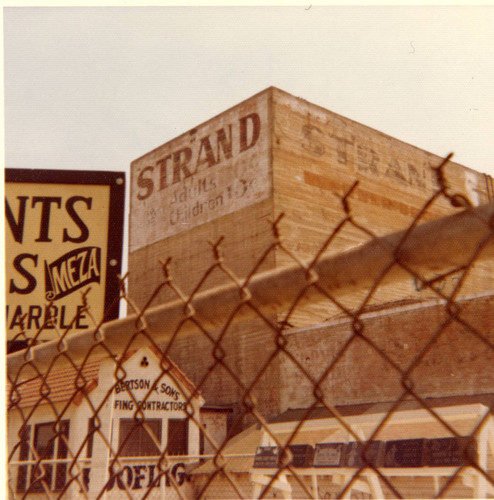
[{"xmin": 428, "ymin": 437, "xmax": 477, "ymax": 467}]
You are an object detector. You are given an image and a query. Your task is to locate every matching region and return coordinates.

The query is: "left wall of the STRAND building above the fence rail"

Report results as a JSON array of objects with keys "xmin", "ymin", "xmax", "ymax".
[{"xmin": 129, "ymin": 91, "xmax": 274, "ymax": 307}]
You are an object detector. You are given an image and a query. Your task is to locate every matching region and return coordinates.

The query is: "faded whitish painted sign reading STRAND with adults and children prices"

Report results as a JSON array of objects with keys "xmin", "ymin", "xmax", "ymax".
[{"xmin": 129, "ymin": 94, "xmax": 271, "ymax": 252}]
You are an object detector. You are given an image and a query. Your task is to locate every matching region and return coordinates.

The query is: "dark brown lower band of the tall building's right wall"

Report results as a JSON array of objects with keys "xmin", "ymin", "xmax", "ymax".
[{"xmin": 281, "ymin": 296, "xmax": 494, "ymax": 410}]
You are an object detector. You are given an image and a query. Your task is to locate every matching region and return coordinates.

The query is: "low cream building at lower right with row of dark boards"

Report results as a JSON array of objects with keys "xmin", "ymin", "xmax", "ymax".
[{"xmin": 191, "ymin": 394, "xmax": 494, "ymax": 499}]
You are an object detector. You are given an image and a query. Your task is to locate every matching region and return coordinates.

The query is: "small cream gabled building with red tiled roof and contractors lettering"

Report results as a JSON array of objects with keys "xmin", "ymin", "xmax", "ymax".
[{"xmin": 8, "ymin": 347, "xmax": 228, "ymax": 498}]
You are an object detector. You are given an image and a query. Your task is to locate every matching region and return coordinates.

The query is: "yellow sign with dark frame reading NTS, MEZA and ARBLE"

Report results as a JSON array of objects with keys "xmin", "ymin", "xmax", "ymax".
[{"xmin": 5, "ymin": 169, "xmax": 125, "ymax": 341}]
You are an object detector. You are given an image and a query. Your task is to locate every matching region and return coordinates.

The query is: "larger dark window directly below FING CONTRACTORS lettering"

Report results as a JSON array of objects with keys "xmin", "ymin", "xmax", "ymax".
[{"xmin": 118, "ymin": 418, "xmax": 161, "ymax": 457}]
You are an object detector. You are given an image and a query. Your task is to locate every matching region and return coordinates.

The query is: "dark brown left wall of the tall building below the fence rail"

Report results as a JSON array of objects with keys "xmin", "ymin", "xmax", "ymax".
[{"xmin": 169, "ymin": 318, "xmax": 285, "ymax": 432}]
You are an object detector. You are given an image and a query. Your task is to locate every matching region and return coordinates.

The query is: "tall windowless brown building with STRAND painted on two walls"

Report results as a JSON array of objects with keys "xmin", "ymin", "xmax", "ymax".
[{"xmin": 125, "ymin": 88, "xmax": 494, "ymax": 422}]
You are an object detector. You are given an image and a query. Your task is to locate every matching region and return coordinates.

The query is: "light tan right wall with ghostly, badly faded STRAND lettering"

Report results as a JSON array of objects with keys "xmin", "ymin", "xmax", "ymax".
[{"xmin": 272, "ymin": 89, "xmax": 494, "ymax": 326}]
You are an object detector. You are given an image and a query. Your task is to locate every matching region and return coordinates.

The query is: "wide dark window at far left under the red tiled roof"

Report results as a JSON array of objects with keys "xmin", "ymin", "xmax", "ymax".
[{"xmin": 17, "ymin": 420, "xmax": 69, "ymax": 493}]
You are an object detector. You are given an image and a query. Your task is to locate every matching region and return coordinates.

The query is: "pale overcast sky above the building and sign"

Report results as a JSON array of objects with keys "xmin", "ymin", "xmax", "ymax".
[{"xmin": 3, "ymin": 0, "xmax": 494, "ymax": 180}]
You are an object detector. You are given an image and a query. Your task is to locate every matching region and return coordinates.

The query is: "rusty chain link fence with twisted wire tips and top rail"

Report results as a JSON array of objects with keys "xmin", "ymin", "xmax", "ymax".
[{"xmin": 7, "ymin": 155, "xmax": 494, "ymax": 498}]
